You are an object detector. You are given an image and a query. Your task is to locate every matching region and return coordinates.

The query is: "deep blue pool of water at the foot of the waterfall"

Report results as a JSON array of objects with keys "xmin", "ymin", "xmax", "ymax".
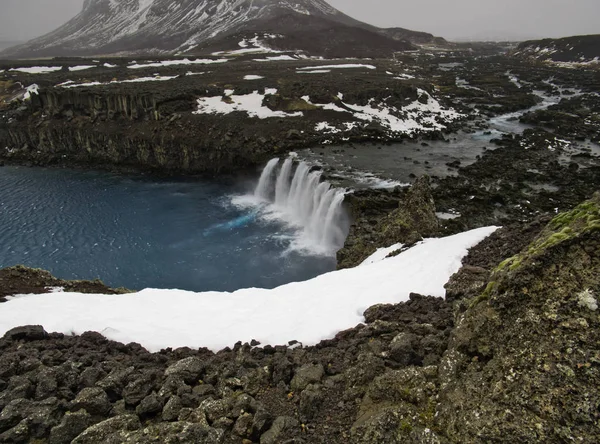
[{"xmin": 0, "ymin": 167, "xmax": 336, "ymax": 291}]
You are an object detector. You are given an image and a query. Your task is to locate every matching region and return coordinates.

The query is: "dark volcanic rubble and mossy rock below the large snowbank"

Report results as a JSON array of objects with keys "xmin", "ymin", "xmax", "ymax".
[{"xmin": 0, "ymin": 194, "xmax": 600, "ymax": 444}]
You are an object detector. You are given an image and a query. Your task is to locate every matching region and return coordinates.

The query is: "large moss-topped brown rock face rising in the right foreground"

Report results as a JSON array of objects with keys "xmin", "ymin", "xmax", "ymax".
[{"xmin": 438, "ymin": 194, "xmax": 600, "ymax": 442}]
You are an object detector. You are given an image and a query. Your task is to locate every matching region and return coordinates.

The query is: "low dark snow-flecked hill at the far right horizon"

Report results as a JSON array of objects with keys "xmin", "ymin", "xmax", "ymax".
[{"xmin": 512, "ymin": 34, "xmax": 600, "ymax": 63}]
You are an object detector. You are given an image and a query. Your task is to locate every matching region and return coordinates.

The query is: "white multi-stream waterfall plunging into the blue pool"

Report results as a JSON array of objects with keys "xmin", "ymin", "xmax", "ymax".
[{"xmin": 254, "ymin": 158, "xmax": 348, "ymax": 254}]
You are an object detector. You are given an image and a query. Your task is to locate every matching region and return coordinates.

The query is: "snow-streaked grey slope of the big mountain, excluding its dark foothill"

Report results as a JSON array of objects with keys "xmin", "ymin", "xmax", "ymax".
[{"xmin": 0, "ymin": 0, "xmax": 424, "ymax": 58}]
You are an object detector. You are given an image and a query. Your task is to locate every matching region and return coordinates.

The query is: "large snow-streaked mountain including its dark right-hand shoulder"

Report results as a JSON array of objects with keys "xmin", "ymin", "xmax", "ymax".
[{"xmin": 0, "ymin": 0, "xmax": 434, "ymax": 58}]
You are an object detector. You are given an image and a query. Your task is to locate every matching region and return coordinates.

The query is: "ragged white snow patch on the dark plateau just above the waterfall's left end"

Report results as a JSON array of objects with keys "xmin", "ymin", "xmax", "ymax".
[{"xmin": 194, "ymin": 88, "xmax": 304, "ymax": 119}]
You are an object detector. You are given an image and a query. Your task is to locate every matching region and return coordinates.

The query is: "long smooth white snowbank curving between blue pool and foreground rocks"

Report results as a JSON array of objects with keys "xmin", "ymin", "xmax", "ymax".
[{"xmin": 0, "ymin": 227, "xmax": 496, "ymax": 351}]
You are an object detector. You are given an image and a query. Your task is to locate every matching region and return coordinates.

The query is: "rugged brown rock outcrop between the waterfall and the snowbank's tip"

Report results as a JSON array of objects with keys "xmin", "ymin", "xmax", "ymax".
[{"xmin": 337, "ymin": 176, "xmax": 439, "ymax": 269}]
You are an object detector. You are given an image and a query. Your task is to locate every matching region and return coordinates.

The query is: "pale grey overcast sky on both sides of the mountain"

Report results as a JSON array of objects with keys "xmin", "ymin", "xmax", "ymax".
[{"xmin": 0, "ymin": 0, "xmax": 600, "ymax": 41}]
